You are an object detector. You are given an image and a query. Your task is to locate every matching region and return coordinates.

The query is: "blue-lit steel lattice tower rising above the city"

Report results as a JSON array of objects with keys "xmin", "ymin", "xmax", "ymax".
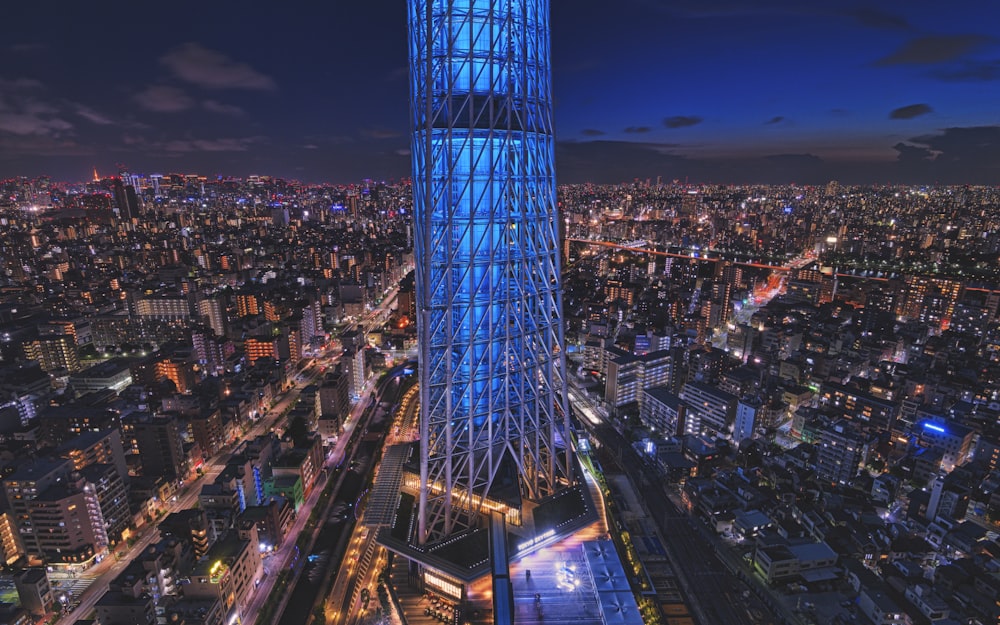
[{"xmin": 409, "ymin": 0, "xmax": 573, "ymax": 543}]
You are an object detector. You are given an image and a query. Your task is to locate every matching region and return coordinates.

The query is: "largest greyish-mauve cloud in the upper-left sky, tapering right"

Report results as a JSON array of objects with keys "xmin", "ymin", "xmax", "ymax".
[{"xmin": 160, "ymin": 43, "xmax": 275, "ymax": 90}]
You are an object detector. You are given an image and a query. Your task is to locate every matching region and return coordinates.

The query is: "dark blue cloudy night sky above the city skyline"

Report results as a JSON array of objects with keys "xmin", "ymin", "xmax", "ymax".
[{"xmin": 0, "ymin": 0, "xmax": 1000, "ymax": 184}]
